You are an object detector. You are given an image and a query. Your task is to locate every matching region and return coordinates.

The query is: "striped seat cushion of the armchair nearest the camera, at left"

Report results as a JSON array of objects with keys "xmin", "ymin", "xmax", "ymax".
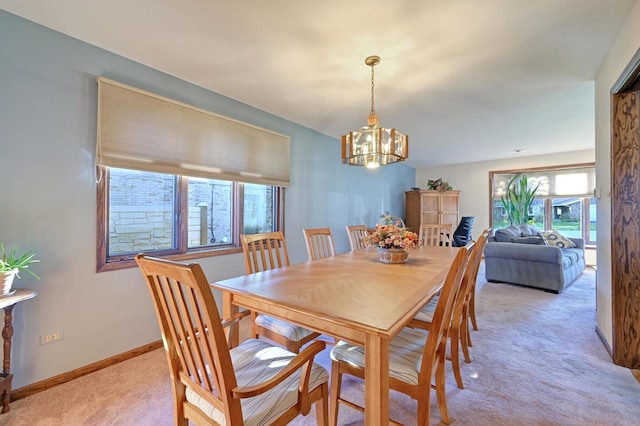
[{"xmin": 186, "ymin": 339, "xmax": 329, "ymax": 426}]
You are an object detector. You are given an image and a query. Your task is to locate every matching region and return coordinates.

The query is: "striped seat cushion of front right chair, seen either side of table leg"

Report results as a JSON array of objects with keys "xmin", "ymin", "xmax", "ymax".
[{"xmin": 331, "ymin": 328, "xmax": 427, "ymax": 385}]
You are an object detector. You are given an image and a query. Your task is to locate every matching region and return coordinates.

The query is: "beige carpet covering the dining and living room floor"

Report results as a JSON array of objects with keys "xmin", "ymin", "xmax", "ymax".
[{"xmin": 0, "ymin": 264, "xmax": 640, "ymax": 426}]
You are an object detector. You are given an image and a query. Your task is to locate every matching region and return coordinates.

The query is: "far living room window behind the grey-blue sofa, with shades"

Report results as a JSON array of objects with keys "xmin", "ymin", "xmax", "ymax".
[{"xmin": 489, "ymin": 164, "xmax": 596, "ymax": 245}]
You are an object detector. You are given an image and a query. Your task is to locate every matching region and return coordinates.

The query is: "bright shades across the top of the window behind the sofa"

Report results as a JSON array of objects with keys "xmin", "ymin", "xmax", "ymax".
[{"xmin": 493, "ymin": 166, "xmax": 596, "ymax": 200}]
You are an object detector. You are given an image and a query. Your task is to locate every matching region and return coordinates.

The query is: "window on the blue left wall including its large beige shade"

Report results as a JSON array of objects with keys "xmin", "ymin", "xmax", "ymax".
[{"xmin": 96, "ymin": 77, "xmax": 291, "ymax": 271}]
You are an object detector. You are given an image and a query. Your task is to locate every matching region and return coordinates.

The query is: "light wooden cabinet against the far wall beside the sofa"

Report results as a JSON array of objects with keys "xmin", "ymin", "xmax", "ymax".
[{"xmin": 405, "ymin": 190, "xmax": 460, "ymax": 232}]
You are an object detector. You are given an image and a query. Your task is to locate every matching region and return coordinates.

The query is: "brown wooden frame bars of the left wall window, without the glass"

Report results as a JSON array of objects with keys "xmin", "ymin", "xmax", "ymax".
[{"xmin": 96, "ymin": 166, "xmax": 285, "ymax": 272}]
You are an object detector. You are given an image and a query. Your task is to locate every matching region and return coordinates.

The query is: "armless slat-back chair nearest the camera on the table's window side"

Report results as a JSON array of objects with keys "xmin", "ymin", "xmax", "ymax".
[{"xmin": 240, "ymin": 231, "xmax": 320, "ymax": 353}]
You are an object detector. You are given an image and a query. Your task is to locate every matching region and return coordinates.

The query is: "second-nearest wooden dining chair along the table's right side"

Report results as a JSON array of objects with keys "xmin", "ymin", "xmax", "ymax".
[{"xmin": 409, "ymin": 234, "xmax": 487, "ymax": 389}]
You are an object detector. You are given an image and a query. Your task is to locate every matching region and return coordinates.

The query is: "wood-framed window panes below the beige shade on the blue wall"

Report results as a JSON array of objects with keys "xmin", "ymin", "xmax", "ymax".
[{"xmin": 98, "ymin": 167, "xmax": 284, "ymax": 271}]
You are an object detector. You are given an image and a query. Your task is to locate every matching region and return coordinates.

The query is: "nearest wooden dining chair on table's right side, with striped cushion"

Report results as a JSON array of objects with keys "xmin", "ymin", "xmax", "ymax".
[{"xmin": 329, "ymin": 243, "xmax": 469, "ymax": 425}]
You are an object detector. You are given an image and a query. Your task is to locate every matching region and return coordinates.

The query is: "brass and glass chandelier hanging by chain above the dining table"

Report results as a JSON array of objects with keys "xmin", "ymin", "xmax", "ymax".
[{"xmin": 342, "ymin": 56, "xmax": 409, "ymax": 168}]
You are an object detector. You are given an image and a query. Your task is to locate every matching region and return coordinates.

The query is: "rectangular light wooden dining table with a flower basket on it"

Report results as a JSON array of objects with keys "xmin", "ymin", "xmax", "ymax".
[{"xmin": 211, "ymin": 246, "xmax": 459, "ymax": 426}]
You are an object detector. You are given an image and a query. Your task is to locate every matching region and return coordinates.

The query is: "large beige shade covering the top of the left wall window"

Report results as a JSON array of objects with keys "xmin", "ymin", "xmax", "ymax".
[{"xmin": 96, "ymin": 77, "xmax": 290, "ymax": 186}]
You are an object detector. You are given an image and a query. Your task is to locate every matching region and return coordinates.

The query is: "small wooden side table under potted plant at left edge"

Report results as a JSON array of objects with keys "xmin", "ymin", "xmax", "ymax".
[{"xmin": 0, "ymin": 288, "xmax": 38, "ymax": 414}]
